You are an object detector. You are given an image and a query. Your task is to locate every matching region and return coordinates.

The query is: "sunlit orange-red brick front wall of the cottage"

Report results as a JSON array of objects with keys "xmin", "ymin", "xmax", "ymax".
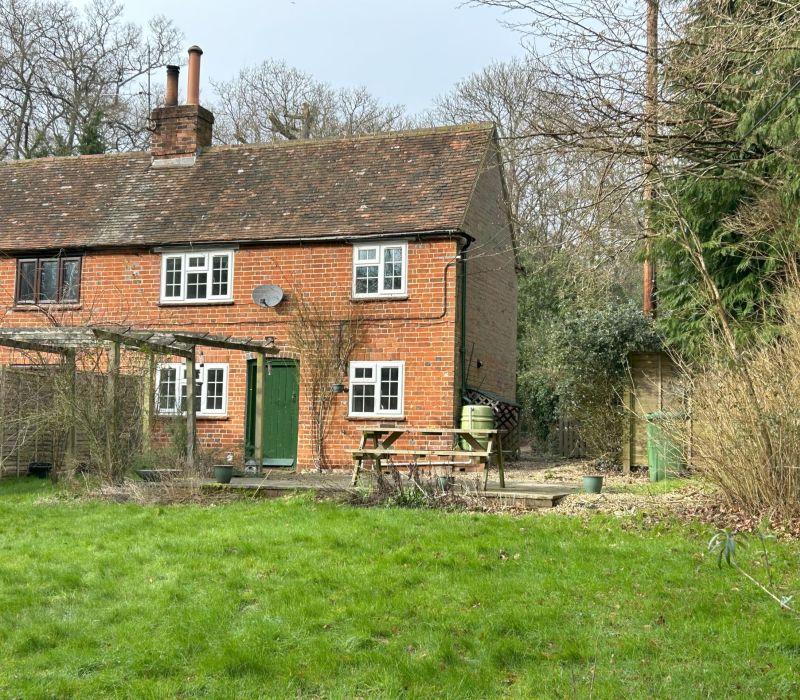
[{"xmin": 0, "ymin": 239, "xmax": 458, "ymax": 468}]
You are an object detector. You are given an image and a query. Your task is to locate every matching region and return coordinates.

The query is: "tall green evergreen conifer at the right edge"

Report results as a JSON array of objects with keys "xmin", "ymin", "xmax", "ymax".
[{"xmin": 657, "ymin": 0, "xmax": 800, "ymax": 358}]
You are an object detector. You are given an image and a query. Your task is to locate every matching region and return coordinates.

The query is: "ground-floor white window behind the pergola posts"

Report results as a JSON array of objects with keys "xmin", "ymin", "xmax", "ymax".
[{"xmin": 156, "ymin": 362, "xmax": 228, "ymax": 417}]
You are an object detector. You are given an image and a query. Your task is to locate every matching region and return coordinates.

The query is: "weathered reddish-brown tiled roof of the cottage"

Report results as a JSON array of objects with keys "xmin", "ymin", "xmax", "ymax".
[{"xmin": 0, "ymin": 124, "xmax": 492, "ymax": 252}]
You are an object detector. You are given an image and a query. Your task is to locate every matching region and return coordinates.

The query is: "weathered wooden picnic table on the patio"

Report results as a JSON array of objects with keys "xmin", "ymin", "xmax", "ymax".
[{"xmin": 351, "ymin": 427, "xmax": 506, "ymax": 491}]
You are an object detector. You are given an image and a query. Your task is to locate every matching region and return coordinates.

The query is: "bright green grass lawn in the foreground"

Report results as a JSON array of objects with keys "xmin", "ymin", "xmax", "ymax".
[{"xmin": 0, "ymin": 482, "xmax": 800, "ymax": 698}]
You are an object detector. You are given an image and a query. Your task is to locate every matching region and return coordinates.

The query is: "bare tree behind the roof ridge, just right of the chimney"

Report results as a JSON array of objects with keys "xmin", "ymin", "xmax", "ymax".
[{"xmin": 211, "ymin": 60, "xmax": 409, "ymax": 144}]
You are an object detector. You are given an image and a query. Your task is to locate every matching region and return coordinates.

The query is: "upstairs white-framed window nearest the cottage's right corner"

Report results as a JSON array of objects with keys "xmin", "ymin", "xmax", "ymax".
[{"xmin": 353, "ymin": 241, "xmax": 408, "ymax": 298}]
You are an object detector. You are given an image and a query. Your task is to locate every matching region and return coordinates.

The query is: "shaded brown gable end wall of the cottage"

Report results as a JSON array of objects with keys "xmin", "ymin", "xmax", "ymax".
[{"xmin": 456, "ymin": 146, "xmax": 517, "ymax": 401}]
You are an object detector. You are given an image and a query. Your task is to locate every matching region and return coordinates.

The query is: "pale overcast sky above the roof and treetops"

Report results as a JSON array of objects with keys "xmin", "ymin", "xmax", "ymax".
[{"xmin": 123, "ymin": 0, "xmax": 523, "ymax": 113}]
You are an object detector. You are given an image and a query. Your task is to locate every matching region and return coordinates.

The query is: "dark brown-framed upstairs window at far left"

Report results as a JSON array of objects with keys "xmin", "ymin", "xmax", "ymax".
[{"xmin": 15, "ymin": 257, "xmax": 81, "ymax": 304}]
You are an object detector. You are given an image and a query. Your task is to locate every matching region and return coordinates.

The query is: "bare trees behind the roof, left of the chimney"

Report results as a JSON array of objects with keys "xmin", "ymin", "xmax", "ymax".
[{"xmin": 0, "ymin": 0, "xmax": 182, "ymax": 159}]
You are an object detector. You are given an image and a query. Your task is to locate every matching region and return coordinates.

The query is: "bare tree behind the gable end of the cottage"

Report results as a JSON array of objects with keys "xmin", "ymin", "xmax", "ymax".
[{"xmin": 428, "ymin": 58, "xmax": 636, "ymax": 294}]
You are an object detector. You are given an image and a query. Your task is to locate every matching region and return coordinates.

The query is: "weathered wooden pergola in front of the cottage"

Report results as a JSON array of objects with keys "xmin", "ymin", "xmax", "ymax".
[{"xmin": 0, "ymin": 326, "xmax": 278, "ymax": 468}]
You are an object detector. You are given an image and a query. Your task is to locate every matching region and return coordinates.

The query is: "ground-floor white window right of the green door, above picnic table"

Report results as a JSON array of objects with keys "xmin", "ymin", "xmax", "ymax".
[{"xmin": 350, "ymin": 362, "xmax": 405, "ymax": 416}]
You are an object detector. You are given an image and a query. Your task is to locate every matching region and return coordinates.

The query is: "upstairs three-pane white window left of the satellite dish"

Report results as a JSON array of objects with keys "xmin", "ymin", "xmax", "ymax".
[{"xmin": 161, "ymin": 250, "xmax": 233, "ymax": 303}]
